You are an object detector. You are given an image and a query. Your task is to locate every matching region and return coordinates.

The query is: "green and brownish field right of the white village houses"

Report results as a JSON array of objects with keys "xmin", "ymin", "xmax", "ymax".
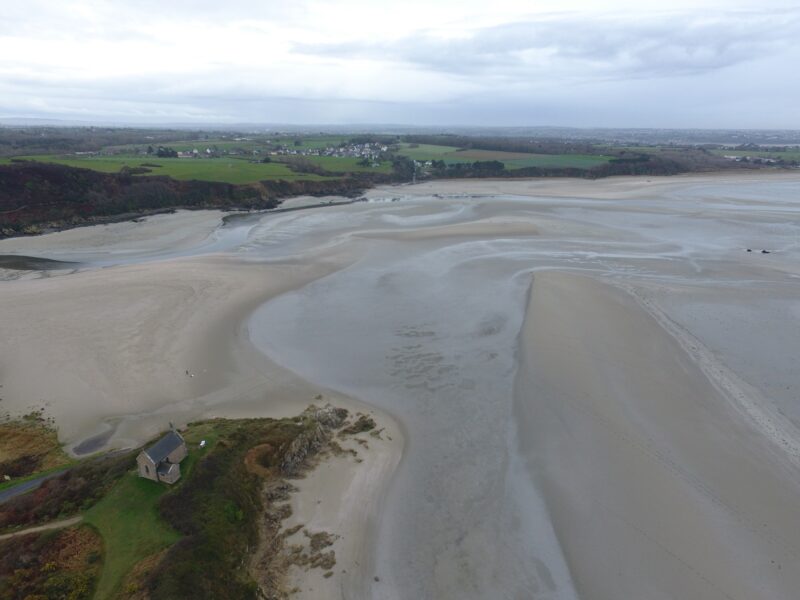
[{"xmin": 398, "ymin": 144, "xmax": 612, "ymax": 170}]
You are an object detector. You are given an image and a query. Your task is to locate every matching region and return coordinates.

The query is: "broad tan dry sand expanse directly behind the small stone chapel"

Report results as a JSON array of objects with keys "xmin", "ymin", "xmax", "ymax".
[{"xmin": 0, "ymin": 257, "xmax": 334, "ymax": 446}]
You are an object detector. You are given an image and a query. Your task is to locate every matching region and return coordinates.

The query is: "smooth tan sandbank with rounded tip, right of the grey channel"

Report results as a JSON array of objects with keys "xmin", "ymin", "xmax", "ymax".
[{"xmin": 515, "ymin": 273, "xmax": 800, "ymax": 600}]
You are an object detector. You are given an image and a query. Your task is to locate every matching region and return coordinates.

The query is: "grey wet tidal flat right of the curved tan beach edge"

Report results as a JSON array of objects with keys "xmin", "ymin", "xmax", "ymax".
[{"xmin": 250, "ymin": 171, "xmax": 798, "ymax": 598}]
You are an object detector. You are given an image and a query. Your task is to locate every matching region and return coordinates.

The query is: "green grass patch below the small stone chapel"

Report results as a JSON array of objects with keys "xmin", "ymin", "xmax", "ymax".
[{"xmin": 84, "ymin": 472, "xmax": 180, "ymax": 600}]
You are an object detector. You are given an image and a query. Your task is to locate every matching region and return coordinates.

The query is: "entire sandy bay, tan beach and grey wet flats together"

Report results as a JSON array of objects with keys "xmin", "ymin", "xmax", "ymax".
[{"xmin": 0, "ymin": 173, "xmax": 800, "ymax": 600}]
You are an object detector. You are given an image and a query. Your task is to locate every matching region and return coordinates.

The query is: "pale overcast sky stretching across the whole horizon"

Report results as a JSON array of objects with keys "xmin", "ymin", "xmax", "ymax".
[{"xmin": 0, "ymin": 0, "xmax": 800, "ymax": 129}]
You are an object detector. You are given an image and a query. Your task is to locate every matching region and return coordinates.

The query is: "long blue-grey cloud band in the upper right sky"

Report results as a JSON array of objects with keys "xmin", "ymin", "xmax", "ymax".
[{"xmin": 294, "ymin": 10, "xmax": 800, "ymax": 78}]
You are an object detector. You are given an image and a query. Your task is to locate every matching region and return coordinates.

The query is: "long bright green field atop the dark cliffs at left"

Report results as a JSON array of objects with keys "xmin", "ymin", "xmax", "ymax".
[{"xmin": 9, "ymin": 155, "xmax": 330, "ymax": 184}]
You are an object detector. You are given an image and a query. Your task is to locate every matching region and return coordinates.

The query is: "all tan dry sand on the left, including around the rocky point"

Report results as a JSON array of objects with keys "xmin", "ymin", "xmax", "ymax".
[{"xmin": 0, "ymin": 206, "xmax": 404, "ymax": 598}]
